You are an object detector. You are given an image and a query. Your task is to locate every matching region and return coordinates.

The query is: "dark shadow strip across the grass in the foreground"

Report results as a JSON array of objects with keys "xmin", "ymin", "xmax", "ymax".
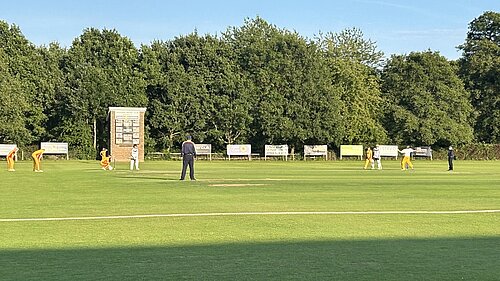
[{"xmin": 0, "ymin": 237, "xmax": 500, "ymax": 280}]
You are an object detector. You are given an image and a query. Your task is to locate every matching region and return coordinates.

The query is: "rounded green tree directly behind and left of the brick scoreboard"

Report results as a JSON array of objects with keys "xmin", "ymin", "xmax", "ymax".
[{"xmin": 54, "ymin": 28, "xmax": 147, "ymax": 157}]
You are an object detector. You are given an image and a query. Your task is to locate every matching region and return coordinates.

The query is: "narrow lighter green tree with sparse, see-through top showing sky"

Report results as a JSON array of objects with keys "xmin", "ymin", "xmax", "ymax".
[{"xmin": 317, "ymin": 29, "xmax": 387, "ymax": 145}]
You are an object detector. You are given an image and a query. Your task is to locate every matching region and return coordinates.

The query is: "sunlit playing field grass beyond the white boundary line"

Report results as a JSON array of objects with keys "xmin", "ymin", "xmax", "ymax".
[{"xmin": 0, "ymin": 161, "xmax": 500, "ymax": 218}]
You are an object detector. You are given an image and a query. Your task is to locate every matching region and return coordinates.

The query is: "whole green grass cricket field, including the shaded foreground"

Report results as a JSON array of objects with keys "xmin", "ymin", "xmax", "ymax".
[{"xmin": 0, "ymin": 160, "xmax": 500, "ymax": 280}]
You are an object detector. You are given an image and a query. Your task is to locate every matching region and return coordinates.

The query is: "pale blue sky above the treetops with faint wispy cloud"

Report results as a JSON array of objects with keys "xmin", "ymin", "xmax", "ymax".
[{"xmin": 0, "ymin": 0, "xmax": 500, "ymax": 60}]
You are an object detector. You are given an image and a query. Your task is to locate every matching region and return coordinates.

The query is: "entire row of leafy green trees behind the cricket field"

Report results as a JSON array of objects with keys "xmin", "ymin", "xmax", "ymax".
[{"xmin": 0, "ymin": 12, "xmax": 500, "ymax": 158}]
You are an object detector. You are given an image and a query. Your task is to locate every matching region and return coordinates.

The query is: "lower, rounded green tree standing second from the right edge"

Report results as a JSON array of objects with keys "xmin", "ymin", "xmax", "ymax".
[{"xmin": 382, "ymin": 51, "xmax": 473, "ymax": 146}]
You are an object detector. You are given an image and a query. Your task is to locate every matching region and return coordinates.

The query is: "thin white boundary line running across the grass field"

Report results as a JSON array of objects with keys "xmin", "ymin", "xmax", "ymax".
[{"xmin": 0, "ymin": 210, "xmax": 500, "ymax": 222}]
